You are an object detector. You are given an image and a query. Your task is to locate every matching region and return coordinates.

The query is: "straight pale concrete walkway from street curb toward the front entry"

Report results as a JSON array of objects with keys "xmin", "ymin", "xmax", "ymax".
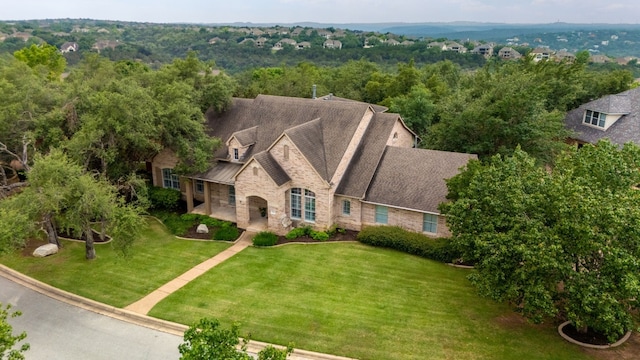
[{"xmin": 125, "ymin": 231, "xmax": 255, "ymax": 315}]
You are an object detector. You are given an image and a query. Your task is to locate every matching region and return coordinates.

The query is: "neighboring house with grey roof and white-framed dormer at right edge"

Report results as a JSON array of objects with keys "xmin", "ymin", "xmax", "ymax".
[{"xmin": 565, "ymin": 87, "xmax": 640, "ymax": 145}]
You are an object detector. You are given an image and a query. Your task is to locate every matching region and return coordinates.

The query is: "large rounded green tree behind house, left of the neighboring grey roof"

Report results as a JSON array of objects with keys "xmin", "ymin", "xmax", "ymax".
[{"xmin": 423, "ymin": 63, "xmax": 567, "ymax": 162}]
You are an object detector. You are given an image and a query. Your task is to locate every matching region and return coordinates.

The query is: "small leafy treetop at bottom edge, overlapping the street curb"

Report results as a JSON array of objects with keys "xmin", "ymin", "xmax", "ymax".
[{"xmin": 178, "ymin": 318, "xmax": 293, "ymax": 360}]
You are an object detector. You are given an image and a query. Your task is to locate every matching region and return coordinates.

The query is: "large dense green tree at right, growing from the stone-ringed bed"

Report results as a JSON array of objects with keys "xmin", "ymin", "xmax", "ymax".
[{"xmin": 441, "ymin": 141, "xmax": 640, "ymax": 341}]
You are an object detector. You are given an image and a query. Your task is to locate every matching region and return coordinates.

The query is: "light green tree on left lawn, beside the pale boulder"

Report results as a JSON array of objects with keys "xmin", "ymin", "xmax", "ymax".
[{"xmin": 0, "ymin": 149, "xmax": 143, "ymax": 259}]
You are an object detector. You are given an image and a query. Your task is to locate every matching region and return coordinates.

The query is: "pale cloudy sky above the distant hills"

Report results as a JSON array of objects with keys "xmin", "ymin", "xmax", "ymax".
[{"xmin": 0, "ymin": 0, "xmax": 640, "ymax": 24}]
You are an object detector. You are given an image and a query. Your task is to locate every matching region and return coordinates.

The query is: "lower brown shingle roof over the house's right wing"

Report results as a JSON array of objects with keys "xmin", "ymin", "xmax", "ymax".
[{"xmin": 365, "ymin": 146, "xmax": 477, "ymax": 213}]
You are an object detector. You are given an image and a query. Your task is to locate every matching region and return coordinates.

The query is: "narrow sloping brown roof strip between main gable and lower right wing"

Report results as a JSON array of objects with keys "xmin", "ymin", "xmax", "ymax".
[{"xmin": 336, "ymin": 113, "xmax": 398, "ymax": 199}]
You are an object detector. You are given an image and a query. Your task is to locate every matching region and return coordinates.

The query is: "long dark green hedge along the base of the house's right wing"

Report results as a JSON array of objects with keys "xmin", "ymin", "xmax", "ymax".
[{"xmin": 357, "ymin": 226, "xmax": 460, "ymax": 263}]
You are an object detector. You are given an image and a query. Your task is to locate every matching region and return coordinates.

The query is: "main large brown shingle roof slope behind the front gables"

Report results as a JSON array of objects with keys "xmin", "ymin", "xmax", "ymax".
[{"xmin": 207, "ymin": 95, "xmax": 370, "ymax": 181}]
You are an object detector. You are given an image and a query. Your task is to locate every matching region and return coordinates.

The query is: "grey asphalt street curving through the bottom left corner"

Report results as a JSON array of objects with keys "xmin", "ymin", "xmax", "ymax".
[{"xmin": 0, "ymin": 276, "xmax": 182, "ymax": 360}]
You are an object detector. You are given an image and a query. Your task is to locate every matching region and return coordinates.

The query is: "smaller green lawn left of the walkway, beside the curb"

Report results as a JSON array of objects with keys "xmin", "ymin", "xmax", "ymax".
[{"xmin": 0, "ymin": 219, "xmax": 230, "ymax": 307}]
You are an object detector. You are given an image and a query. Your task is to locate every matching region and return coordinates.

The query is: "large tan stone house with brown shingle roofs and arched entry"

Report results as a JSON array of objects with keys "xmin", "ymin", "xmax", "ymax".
[{"xmin": 150, "ymin": 95, "xmax": 476, "ymax": 236}]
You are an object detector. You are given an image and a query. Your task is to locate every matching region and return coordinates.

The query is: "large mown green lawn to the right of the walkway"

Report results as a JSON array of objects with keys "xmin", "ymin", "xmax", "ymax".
[{"xmin": 150, "ymin": 243, "xmax": 590, "ymax": 360}]
